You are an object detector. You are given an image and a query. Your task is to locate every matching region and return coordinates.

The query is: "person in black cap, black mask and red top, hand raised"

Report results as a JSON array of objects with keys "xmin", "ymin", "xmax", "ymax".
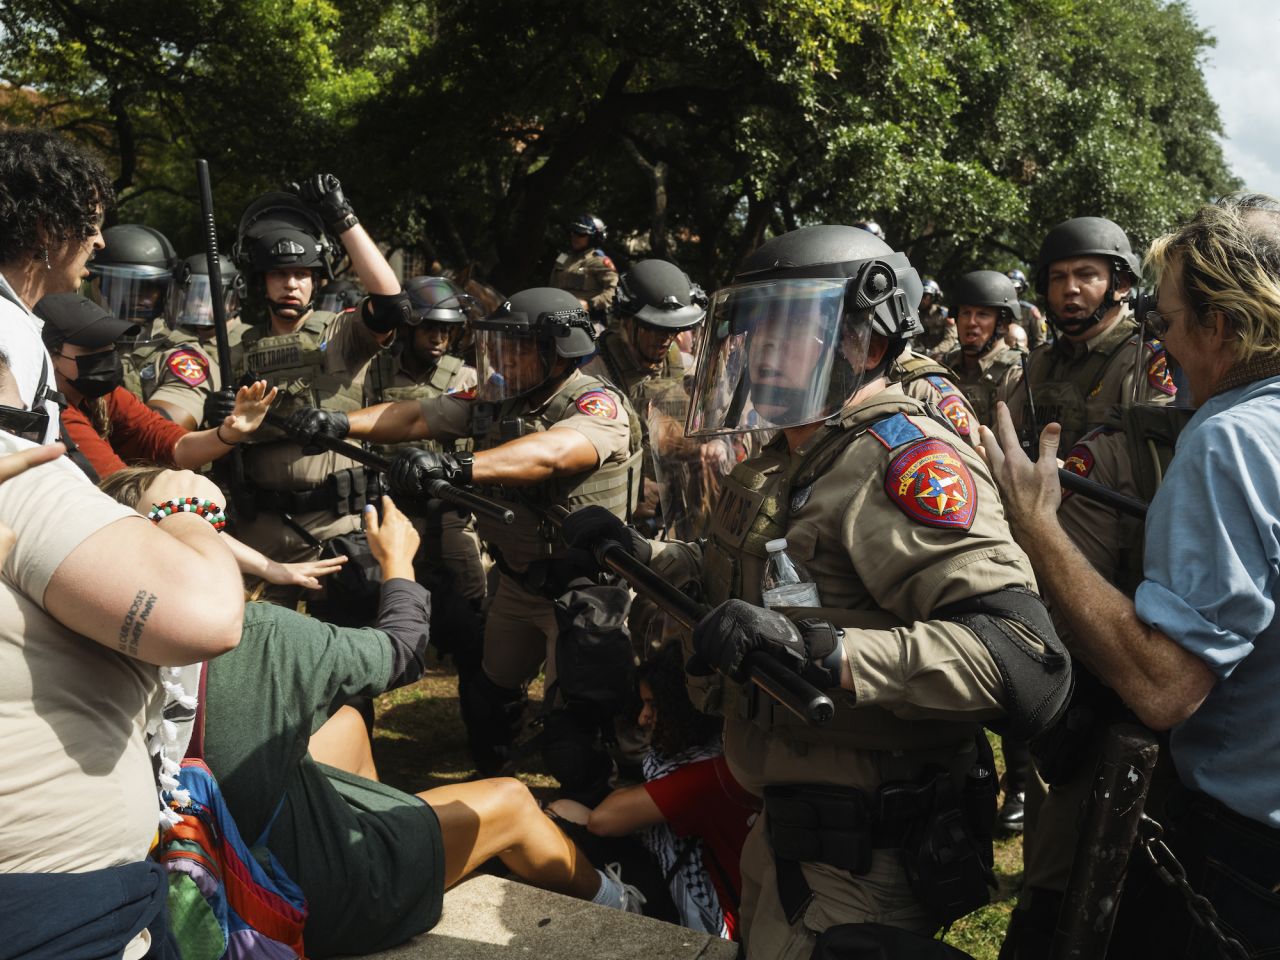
[{"xmin": 36, "ymin": 293, "xmax": 276, "ymax": 483}]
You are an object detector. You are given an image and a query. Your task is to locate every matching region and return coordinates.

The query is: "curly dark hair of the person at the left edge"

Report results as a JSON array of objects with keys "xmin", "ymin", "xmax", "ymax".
[{"xmin": 0, "ymin": 129, "xmax": 115, "ymax": 264}]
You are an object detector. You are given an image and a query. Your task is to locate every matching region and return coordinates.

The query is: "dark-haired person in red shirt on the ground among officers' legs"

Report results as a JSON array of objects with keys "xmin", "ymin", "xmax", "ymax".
[{"xmin": 548, "ymin": 643, "xmax": 759, "ymax": 940}]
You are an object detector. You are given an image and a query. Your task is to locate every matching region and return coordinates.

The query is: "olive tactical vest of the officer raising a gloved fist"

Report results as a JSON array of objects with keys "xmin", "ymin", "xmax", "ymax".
[{"xmin": 237, "ymin": 310, "xmax": 364, "ymax": 416}]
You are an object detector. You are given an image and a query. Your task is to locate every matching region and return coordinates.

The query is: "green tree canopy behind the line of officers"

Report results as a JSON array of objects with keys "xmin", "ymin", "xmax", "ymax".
[{"xmin": 0, "ymin": 0, "xmax": 1235, "ymax": 289}]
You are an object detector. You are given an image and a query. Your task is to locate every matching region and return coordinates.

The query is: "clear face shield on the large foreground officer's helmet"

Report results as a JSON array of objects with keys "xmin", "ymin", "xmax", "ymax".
[{"xmin": 686, "ymin": 278, "xmax": 872, "ymax": 436}]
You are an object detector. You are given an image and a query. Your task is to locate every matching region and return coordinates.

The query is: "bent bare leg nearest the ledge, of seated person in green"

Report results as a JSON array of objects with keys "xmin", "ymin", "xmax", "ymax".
[{"xmin": 419, "ymin": 777, "xmax": 600, "ymax": 900}]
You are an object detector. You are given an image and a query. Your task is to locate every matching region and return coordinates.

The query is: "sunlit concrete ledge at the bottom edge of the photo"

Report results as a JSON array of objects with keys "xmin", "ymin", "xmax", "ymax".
[{"xmin": 371, "ymin": 874, "xmax": 737, "ymax": 960}]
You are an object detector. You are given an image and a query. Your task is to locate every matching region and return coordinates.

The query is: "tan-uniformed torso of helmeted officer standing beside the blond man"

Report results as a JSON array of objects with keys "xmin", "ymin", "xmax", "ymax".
[{"xmin": 1000, "ymin": 307, "xmax": 1175, "ymax": 449}]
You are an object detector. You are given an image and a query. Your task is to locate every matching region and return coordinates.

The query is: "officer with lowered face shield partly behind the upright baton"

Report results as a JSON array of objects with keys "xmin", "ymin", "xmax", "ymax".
[{"xmin": 124, "ymin": 253, "xmax": 246, "ymax": 430}]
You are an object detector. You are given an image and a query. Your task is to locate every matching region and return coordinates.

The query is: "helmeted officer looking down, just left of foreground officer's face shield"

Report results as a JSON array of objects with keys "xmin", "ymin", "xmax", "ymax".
[{"xmin": 584, "ymin": 260, "xmax": 707, "ymax": 535}]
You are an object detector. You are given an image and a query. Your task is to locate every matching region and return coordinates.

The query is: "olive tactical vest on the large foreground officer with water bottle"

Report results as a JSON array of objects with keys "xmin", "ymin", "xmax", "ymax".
[{"xmin": 703, "ymin": 397, "xmax": 978, "ymax": 756}]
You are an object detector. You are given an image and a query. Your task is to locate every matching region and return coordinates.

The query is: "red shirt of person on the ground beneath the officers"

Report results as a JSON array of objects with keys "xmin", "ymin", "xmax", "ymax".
[{"xmin": 644, "ymin": 756, "xmax": 759, "ymax": 940}]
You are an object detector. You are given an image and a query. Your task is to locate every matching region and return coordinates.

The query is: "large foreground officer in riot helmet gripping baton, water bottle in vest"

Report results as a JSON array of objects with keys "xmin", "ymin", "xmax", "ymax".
[{"xmin": 564, "ymin": 227, "xmax": 1070, "ymax": 957}]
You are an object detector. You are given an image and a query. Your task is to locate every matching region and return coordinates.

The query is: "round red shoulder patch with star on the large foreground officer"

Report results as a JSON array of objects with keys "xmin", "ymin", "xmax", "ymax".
[{"xmin": 884, "ymin": 440, "xmax": 978, "ymax": 530}]
